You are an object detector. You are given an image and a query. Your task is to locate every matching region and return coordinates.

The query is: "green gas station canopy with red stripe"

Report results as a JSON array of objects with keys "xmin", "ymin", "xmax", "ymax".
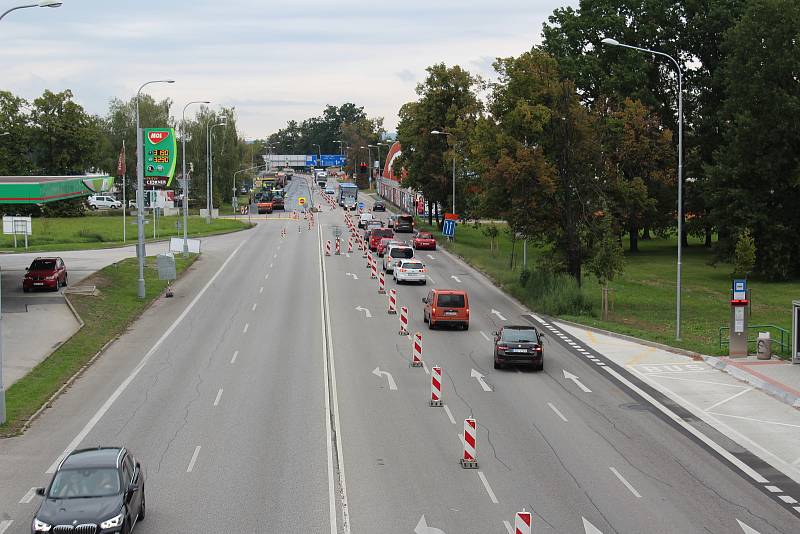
[{"xmin": 0, "ymin": 174, "xmax": 114, "ymax": 204}]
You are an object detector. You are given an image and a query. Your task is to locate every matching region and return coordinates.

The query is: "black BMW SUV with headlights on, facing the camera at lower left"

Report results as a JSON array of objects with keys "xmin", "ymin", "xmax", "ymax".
[{"xmin": 31, "ymin": 447, "xmax": 145, "ymax": 534}]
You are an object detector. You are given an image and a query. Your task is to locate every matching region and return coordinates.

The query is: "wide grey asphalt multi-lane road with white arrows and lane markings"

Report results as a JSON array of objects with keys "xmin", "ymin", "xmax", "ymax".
[{"xmin": 0, "ymin": 177, "xmax": 800, "ymax": 534}]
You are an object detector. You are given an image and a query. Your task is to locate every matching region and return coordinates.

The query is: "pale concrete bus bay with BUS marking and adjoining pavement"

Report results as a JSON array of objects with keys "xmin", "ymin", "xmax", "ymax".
[{"xmin": 553, "ymin": 321, "xmax": 800, "ymax": 483}]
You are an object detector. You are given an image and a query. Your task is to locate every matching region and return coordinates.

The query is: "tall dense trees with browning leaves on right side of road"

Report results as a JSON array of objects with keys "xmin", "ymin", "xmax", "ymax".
[{"xmin": 397, "ymin": 0, "xmax": 800, "ymax": 281}]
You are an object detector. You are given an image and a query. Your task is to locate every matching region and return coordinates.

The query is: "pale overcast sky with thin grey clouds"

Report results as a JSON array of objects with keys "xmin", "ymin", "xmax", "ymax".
[{"xmin": 0, "ymin": 0, "xmax": 577, "ymax": 138}]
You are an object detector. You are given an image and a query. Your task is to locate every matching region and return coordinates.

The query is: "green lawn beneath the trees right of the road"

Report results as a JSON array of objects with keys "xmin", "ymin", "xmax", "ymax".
[{"xmin": 421, "ymin": 218, "xmax": 800, "ymax": 355}]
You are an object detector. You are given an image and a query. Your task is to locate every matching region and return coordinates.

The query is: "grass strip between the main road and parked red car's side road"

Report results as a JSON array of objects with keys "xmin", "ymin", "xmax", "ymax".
[{"xmin": 0, "ymin": 255, "xmax": 196, "ymax": 437}]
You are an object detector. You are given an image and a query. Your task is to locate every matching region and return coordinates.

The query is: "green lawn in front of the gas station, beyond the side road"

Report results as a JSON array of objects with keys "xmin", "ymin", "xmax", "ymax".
[{"xmin": 0, "ymin": 214, "xmax": 248, "ymax": 252}]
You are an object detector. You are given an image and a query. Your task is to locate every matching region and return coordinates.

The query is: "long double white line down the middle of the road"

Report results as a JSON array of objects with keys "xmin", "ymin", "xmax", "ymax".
[{"xmin": 317, "ymin": 225, "xmax": 350, "ymax": 534}]
